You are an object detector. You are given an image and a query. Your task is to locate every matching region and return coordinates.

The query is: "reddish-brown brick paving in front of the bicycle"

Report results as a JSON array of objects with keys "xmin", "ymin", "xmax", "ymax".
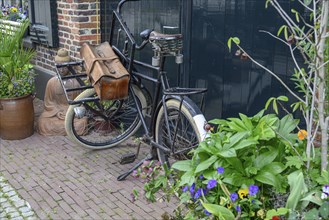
[{"xmin": 0, "ymin": 133, "xmax": 175, "ymax": 219}]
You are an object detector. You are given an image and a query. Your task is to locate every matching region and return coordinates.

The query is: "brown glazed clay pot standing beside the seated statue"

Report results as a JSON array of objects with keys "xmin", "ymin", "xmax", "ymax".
[{"xmin": 0, "ymin": 95, "xmax": 34, "ymax": 140}]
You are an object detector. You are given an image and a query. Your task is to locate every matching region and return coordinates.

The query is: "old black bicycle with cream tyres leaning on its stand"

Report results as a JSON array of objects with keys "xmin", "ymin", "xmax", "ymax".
[{"xmin": 56, "ymin": 0, "xmax": 207, "ymax": 180}]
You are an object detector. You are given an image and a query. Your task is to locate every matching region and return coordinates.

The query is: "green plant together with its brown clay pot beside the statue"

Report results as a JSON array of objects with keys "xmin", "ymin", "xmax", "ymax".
[{"xmin": 0, "ymin": 20, "xmax": 34, "ymax": 140}]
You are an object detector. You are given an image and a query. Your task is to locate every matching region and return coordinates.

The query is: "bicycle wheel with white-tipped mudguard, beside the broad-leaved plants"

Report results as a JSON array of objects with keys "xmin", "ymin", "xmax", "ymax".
[{"xmin": 155, "ymin": 99, "xmax": 206, "ymax": 167}]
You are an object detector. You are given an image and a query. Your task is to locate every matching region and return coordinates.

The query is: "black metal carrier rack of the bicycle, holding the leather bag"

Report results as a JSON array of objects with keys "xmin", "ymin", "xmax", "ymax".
[{"xmin": 55, "ymin": 61, "xmax": 99, "ymax": 105}]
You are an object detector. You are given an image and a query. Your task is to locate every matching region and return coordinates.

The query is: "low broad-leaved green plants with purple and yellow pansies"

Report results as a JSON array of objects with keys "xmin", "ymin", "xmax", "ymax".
[{"xmin": 136, "ymin": 106, "xmax": 329, "ymax": 219}]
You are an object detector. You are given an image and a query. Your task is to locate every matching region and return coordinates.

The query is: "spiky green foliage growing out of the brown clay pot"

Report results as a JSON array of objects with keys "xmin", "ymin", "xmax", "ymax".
[{"xmin": 0, "ymin": 20, "xmax": 34, "ymax": 98}]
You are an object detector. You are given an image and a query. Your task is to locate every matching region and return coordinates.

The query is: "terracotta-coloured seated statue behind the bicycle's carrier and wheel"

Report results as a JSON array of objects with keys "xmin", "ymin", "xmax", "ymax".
[{"xmin": 36, "ymin": 49, "xmax": 86, "ymax": 136}]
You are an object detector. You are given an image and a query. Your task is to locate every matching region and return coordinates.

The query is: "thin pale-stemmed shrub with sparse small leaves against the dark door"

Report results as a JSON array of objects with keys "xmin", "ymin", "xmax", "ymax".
[{"xmin": 227, "ymin": 0, "xmax": 329, "ymax": 170}]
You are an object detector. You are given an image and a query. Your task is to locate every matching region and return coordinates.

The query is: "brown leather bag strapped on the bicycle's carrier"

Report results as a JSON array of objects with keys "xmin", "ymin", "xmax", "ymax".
[{"xmin": 80, "ymin": 42, "xmax": 130, "ymax": 100}]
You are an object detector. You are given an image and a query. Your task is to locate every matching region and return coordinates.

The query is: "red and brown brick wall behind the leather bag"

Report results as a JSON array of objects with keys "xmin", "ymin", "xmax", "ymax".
[{"xmin": 34, "ymin": 0, "xmax": 101, "ymax": 70}]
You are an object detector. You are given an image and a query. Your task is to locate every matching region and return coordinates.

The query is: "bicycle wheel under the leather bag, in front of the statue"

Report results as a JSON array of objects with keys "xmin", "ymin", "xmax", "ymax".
[{"xmin": 65, "ymin": 85, "xmax": 147, "ymax": 149}]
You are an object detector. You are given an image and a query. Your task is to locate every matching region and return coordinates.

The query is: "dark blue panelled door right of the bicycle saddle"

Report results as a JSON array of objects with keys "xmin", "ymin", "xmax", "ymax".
[{"xmin": 185, "ymin": 0, "xmax": 300, "ymax": 118}]
